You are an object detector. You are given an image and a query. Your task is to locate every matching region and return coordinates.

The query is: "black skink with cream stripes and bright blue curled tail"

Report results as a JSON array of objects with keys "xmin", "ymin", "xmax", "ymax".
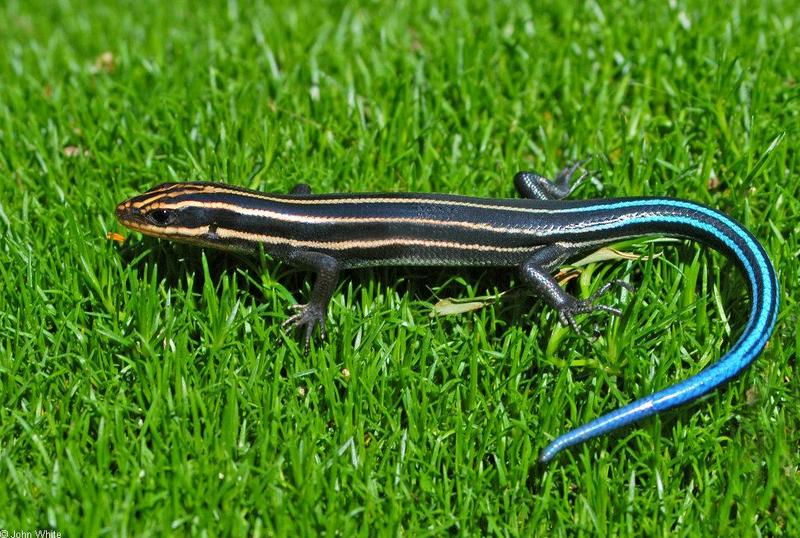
[{"xmin": 116, "ymin": 166, "xmax": 778, "ymax": 462}]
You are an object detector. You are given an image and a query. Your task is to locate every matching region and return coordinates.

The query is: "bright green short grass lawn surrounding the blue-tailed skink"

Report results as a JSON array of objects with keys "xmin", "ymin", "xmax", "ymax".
[{"xmin": 0, "ymin": 0, "xmax": 800, "ymax": 536}]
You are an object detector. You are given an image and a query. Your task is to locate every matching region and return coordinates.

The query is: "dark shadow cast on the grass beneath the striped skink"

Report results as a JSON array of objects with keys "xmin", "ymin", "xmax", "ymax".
[{"xmin": 114, "ymin": 238, "xmax": 749, "ymax": 356}]
